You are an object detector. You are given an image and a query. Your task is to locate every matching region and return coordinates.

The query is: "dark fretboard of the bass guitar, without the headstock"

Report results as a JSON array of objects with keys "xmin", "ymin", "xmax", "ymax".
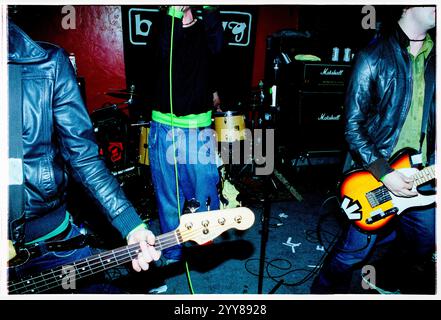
[{"xmin": 8, "ymin": 230, "xmax": 184, "ymax": 294}]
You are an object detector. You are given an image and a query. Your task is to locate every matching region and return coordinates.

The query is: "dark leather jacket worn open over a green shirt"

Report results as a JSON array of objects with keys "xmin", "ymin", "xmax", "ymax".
[{"xmin": 345, "ymin": 26, "xmax": 436, "ymax": 179}]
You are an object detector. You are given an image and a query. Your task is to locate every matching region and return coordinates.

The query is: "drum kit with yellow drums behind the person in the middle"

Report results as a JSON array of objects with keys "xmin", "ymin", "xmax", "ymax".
[{"xmin": 91, "ymin": 86, "xmax": 300, "ymax": 216}]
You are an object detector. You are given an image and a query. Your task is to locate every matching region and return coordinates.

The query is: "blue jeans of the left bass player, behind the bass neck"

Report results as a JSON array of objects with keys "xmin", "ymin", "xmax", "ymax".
[{"xmin": 9, "ymin": 224, "xmax": 121, "ymax": 294}]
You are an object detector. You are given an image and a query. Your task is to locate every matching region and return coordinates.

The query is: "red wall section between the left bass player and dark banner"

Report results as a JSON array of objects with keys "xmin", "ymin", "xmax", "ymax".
[{"xmin": 20, "ymin": 6, "xmax": 126, "ymax": 112}]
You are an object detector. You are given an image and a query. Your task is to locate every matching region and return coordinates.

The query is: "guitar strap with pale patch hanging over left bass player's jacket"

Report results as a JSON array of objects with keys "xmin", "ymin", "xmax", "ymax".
[{"xmin": 8, "ymin": 64, "xmax": 25, "ymax": 247}]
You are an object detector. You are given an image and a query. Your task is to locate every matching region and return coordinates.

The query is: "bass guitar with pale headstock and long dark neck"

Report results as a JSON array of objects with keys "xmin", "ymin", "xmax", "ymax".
[{"xmin": 8, "ymin": 207, "xmax": 254, "ymax": 294}]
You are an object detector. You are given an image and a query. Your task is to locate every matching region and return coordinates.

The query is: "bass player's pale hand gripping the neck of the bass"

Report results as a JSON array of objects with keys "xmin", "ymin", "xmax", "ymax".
[{"xmin": 127, "ymin": 228, "xmax": 161, "ymax": 272}]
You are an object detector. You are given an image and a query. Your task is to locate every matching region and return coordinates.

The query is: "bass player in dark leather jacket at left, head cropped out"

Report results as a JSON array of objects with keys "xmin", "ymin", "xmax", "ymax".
[{"xmin": 8, "ymin": 21, "xmax": 160, "ymax": 292}]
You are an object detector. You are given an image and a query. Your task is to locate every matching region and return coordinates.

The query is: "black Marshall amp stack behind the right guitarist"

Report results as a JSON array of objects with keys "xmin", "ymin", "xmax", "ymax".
[{"xmin": 279, "ymin": 61, "xmax": 351, "ymax": 162}]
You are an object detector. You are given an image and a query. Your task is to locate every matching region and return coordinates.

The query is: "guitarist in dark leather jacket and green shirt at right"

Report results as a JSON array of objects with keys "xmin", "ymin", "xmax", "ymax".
[{"xmin": 311, "ymin": 7, "xmax": 436, "ymax": 293}]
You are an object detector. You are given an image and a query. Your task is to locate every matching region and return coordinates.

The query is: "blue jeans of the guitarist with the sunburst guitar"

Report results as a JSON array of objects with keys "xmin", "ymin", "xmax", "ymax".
[{"xmin": 311, "ymin": 184, "xmax": 435, "ymax": 293}]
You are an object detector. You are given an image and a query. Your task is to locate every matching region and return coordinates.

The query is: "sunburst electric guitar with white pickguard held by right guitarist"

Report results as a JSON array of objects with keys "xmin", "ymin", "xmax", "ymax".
[{"xmin": 340, "ymin": 148, "xmax": 435, "ymax": 232}]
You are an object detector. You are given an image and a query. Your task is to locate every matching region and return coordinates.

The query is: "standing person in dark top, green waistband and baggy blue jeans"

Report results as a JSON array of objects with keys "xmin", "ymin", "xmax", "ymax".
[{"xmin": 149, "ymin": 6, "xmax": 223, "ymax": 262}]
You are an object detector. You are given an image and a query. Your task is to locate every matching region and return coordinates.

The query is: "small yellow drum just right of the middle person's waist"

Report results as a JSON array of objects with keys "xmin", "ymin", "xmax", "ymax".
[{"xmin": 214, "ymin": 111, "xmax": 245, "ymax": 142}]
